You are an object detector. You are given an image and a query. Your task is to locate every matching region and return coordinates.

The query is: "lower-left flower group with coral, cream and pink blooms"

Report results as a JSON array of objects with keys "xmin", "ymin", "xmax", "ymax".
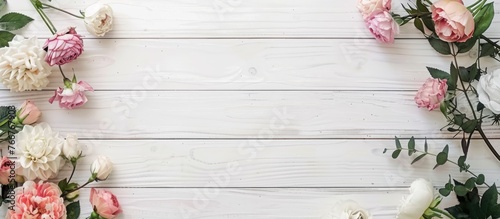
[{"xmin": 0, "ymin": 101, "xmax": 122, "ymax": 219}]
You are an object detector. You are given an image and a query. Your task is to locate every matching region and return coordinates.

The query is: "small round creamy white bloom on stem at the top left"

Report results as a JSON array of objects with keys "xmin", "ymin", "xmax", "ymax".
[{"xmin": 84, "ymin": 3, "xmax": 113, "ymax": 36}]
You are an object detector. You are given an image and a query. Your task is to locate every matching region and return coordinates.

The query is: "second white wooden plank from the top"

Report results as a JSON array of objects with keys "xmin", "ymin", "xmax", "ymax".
[{"xmin": 0, "ymin": 39, "xmax": 490, "ymax": 90}]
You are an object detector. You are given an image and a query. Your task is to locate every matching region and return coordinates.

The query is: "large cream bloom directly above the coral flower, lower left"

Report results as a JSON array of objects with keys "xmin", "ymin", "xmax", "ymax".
[{"xmin": 16, "ymin": 123, "xmax": 64, "ymax": 180}]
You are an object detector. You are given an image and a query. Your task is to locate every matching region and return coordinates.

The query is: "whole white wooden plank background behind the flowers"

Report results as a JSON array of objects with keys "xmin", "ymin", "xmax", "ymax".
[{"xmin": 0, "ymin": 0, "xmax": 500, "ymax": 219}]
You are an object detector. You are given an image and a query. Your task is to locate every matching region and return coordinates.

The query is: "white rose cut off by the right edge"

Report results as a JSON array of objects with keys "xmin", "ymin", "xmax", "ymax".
[{"xmin": 477, "ymin": 69, "xmax": 500, "ymax": 114}]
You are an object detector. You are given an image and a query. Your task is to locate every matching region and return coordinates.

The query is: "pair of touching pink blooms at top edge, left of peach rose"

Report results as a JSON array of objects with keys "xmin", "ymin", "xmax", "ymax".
[{"xmin": 358, "ymin": 0, "xmax": 399, "ymax": 43}]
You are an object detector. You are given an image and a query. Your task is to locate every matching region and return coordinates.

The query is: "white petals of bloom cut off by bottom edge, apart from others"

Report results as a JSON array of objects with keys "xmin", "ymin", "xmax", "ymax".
[{"xmin": 327, "ymin": 200, "xmax": 372, "ymax": 219}]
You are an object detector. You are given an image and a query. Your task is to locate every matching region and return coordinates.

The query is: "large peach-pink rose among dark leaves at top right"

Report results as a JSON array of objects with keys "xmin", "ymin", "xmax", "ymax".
[{"xmin": 431, "ymin": 0, "xmax": 474, "ymax": 43}]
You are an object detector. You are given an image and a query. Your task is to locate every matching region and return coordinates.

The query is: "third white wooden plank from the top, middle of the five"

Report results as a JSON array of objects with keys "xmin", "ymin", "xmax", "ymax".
[{"xmin": 0, "ymin": 91, "xmax": 500, "ymax": 139}]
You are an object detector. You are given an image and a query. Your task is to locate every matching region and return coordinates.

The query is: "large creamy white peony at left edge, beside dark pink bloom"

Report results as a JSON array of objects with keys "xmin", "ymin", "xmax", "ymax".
[{"xmin": 0, "ymin": 36, "xmax": 52, "ymax": 92}]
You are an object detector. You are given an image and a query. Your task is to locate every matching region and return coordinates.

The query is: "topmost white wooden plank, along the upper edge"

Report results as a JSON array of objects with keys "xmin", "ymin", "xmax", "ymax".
[{"xmin": 9, "ymin": 0, "xmax": 500, "ymax": 38}]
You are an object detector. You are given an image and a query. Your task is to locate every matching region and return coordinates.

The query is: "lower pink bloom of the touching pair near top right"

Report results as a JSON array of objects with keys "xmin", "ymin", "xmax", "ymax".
[{"xmin": 365, "ymin": 11, "xmax": 399, "ymax": 43}]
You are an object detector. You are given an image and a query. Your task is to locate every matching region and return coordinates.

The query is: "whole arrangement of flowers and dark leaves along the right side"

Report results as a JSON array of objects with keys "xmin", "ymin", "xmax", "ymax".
[{"xmin": 352, "ymin": 0, "xmax": 500, "ymax": 219}]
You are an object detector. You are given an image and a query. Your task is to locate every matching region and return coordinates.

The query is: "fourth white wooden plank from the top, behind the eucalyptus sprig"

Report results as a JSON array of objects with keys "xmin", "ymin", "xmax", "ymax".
[{"xmin": 5, "ymin": 140, "xmax": 500, "ymax": 188}]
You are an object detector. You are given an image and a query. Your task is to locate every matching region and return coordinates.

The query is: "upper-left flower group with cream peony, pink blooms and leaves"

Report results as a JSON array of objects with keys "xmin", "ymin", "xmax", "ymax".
[{"xmin": 0, "ymin": 0, "xmax": 113, "ymax": 109}]
